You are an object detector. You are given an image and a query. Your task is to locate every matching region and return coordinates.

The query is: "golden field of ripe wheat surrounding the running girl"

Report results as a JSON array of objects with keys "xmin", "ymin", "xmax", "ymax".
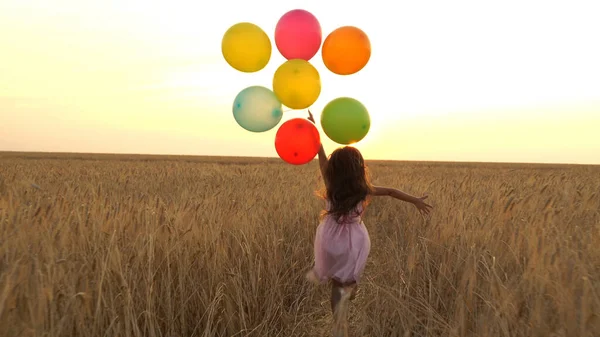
[{"xmin": 0, "ymin": 153, "xmax": 600, "ymax": 337}]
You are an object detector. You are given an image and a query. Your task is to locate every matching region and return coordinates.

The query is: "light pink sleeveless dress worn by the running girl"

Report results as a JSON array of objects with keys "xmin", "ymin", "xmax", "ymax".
[{"xmin": 313, "ymin": 202, "xmax": 371, "ymax": 284}]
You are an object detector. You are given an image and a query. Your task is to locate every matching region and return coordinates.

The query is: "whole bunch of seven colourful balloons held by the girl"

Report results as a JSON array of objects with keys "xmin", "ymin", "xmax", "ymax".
[{"xmin": 221, "ymin": 9, "xmax": 371, "ymax": 165}]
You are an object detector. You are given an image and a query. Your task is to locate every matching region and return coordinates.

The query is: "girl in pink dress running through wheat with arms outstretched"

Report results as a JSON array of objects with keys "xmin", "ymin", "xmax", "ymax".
[{"xmin": 307, "ymin": 110, "xmax": 432, "ymax": 336}]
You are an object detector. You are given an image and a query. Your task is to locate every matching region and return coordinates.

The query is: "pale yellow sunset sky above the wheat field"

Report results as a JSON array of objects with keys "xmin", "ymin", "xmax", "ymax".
[{"xmin": 0, "ymin": 0, "xmax": 600, "ymax": 164}]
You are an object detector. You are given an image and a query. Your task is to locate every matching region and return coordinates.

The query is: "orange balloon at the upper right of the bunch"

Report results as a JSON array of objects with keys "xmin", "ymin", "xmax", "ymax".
[{"xmin": 321, "ymin": 26, "xmax": 371, "ymax": 75}]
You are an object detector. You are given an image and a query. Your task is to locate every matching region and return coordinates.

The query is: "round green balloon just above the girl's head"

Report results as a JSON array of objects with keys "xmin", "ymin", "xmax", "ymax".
[{"xmin": 321, "ymin": 97, "xmax": 371, "ymax": 145}]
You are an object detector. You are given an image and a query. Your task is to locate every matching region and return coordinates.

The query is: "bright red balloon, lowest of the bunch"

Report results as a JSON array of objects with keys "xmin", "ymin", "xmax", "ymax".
[{"xmin": 275, "ymin": 118, "xmax": 321, "ymax": 165}]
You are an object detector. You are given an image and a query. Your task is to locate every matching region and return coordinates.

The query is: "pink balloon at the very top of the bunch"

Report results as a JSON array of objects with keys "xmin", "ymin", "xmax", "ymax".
[{"xmin": 275, "ymin": 9, "xmax": 322, "ymax": 61}]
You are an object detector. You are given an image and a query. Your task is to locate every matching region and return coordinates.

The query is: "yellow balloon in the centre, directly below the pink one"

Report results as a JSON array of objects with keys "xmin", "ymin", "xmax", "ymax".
[{"xmin": 273, "ymin": 59, "xmax": 321, "ymax": 109}]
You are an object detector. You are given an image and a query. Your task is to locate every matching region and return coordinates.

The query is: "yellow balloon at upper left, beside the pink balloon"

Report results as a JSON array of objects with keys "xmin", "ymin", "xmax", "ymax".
[{"xmin": 221, "ymin": 22, "xmax": 271, "ymax": 73}]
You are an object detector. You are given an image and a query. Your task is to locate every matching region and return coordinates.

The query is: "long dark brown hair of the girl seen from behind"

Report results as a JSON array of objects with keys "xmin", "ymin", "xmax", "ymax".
[{"xmin": 324, "ymin": 146, "xmax": 372, "ymax": 221}]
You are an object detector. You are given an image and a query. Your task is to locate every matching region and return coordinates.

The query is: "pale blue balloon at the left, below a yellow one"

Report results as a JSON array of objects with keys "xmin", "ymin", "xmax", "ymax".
[{"xmin": 233, "ymin": 86, "xmax": 283, "ymax": 132}]
